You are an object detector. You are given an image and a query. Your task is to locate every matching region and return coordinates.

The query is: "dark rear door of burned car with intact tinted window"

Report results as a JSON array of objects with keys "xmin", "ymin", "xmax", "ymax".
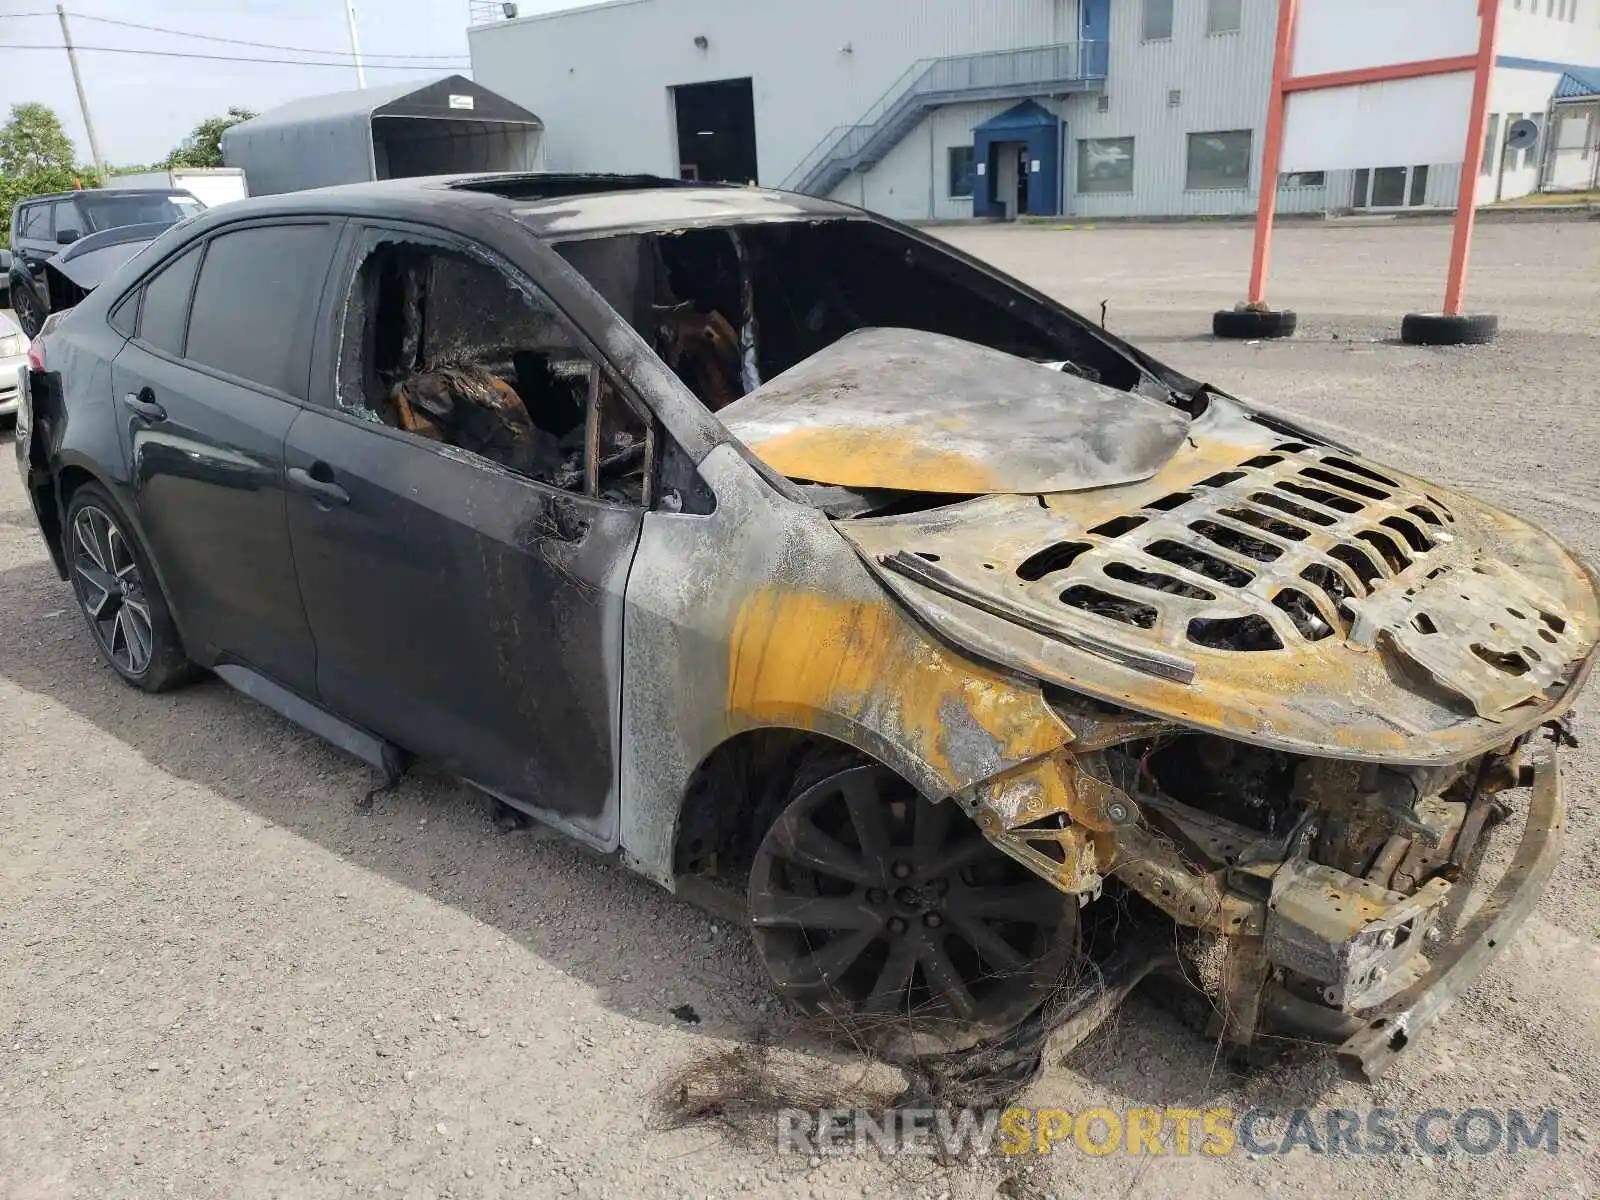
[{"xmin": 112, "ymin": 219, "xmax": 339, "ymax": 696}]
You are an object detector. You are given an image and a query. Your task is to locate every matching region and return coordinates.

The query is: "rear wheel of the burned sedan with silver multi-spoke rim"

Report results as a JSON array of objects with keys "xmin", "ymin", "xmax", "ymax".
[{"xmin": 61, "ymin": 483, "xmax": 198, "ymax": 691}]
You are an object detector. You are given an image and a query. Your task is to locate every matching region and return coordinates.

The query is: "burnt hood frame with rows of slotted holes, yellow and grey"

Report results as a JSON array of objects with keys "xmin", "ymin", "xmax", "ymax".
[{"xmin": 837, "ymin": 397, "xmax": 1600, "ymax": 765}]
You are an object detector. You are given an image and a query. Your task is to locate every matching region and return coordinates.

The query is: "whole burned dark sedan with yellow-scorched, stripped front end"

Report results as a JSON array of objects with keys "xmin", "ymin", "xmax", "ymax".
[{"xmin": 16, "ymin": 176, "xmax": 1600, "ymax": 1074}]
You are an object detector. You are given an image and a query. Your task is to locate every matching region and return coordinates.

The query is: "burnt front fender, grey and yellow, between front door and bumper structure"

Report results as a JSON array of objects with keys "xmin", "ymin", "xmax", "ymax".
[{"xmin": 619, "ymin": 445, "xmax": 1075, "ymax": 886}]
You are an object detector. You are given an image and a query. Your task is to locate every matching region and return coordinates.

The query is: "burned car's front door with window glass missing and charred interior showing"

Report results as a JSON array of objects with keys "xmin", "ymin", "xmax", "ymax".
[{"xmin": 285, "ymin": 224, "xmax": 651, "ymax": 848}]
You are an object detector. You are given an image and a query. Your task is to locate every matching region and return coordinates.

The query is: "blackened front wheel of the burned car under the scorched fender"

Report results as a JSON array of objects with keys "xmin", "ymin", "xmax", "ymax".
[{"xmin": 749, "ymin": 763, "xmax": 1078, "ymax": 1058}]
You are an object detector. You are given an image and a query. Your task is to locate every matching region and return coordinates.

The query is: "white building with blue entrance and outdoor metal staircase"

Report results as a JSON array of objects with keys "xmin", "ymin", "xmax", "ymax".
[{"xmin": 469, "ymin": 0, "xmax": 1600, "ymax": 219}]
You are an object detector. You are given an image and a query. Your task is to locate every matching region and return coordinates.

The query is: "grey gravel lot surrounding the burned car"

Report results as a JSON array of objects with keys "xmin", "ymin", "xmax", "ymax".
[{"xmin": 0, "ymin": 221, "xmax": 1600, "ymax": 1200}]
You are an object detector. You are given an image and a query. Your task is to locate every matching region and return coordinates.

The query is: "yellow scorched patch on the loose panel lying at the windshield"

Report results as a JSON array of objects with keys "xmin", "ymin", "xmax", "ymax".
[{"xmin": 750, "ymin": 429, "xmax": 1006, "ymax": 494}]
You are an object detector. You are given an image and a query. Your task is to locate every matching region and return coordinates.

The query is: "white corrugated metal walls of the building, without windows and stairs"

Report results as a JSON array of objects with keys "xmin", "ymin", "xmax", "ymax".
[{"xmin": 469, "ymin": 0, "xmax": 1586, "ymax": 219}]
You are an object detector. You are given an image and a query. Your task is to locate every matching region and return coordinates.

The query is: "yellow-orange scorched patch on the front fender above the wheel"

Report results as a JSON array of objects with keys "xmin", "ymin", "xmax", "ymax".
[{"xmin": 728, "ymin": 589, "xmax": 1070, "ymax": 789}]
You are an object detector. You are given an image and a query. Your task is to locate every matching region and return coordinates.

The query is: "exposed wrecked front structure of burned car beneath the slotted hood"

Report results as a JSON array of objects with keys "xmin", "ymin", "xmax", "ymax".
[{"xmin": 1011, "ymin": 693, "xmax": 1570, "ymax": 1075}]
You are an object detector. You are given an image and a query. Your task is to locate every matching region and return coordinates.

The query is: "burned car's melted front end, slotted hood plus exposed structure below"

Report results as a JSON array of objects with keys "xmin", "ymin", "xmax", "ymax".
[{"xmin": 838, "ymin": 397, "xmax": 1600, "ymax": 1075}]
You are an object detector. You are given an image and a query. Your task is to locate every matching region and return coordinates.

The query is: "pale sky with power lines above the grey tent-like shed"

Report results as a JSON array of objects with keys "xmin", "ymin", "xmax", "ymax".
[{"xmin": 0, "ymin": 0, "xmax": 521, "ymax": 165}]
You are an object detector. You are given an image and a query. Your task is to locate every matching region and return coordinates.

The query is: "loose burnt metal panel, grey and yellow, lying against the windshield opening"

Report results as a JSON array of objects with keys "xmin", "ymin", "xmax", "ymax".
[{"xmin": 718, "ymin": 328, "xmax": 1189, "ymax": 494}]
